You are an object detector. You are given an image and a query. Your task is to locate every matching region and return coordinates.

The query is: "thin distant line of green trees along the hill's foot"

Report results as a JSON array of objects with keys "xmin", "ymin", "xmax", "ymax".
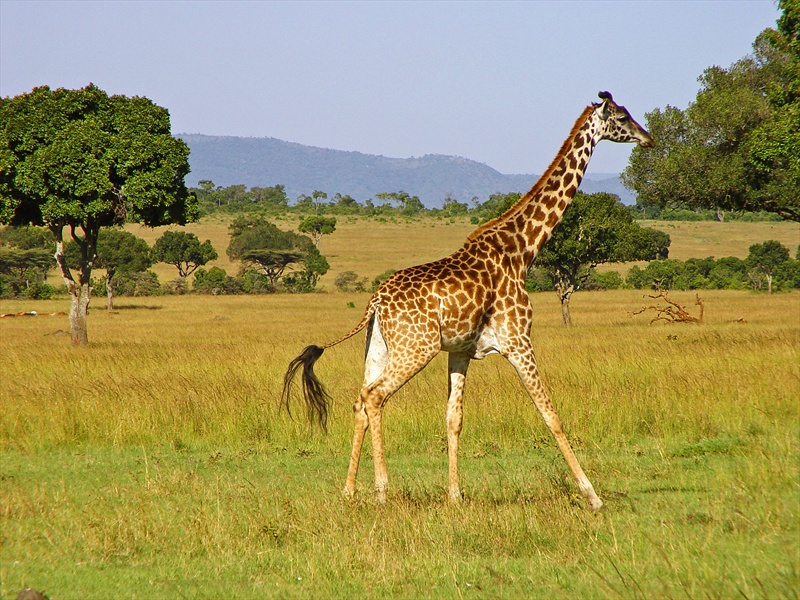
[{"xmin": 195, "ymin": 180, "xmax": 782, "ymax": 224}]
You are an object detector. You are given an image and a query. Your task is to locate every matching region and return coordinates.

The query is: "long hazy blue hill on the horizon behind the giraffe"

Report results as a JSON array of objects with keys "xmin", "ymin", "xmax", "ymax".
[{"xmin": 177, "ymin": 134, "xmax": 634, "ymax": 208}]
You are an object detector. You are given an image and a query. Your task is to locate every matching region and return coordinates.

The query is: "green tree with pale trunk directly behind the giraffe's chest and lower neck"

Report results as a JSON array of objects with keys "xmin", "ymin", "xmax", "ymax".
[{"xmin": 534, "ymin": 192, "xmax": 670, "ymax": 325}]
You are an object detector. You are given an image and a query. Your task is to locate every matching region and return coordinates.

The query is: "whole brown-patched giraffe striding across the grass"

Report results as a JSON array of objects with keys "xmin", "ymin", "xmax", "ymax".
[{"xmin": 282, "ymin": 92, "xmax": 654, "ymax": 510}]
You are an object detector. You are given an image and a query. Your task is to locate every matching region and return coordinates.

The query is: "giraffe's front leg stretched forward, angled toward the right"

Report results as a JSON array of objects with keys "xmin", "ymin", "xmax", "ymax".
[{"xmin": 506, "ymin": 347, "xmax": 603, "ymax": 510}]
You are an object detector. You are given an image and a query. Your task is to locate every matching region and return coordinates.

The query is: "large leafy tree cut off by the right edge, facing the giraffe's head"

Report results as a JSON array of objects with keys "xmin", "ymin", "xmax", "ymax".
[{"xmin": 623, "ymin": 0, "xmax": 800, "ymax": 221}]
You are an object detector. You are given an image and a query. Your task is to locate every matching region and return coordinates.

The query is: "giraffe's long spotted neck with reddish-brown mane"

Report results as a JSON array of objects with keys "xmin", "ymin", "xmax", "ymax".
[{"xmin": 467, "ymin": 106, "xmax": 599, "ymax": 270}]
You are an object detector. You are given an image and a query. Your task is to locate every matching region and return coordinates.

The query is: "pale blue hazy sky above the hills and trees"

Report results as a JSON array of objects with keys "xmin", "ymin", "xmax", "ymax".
[{"xmin": 0, "ymin": 0, "xmax": 779, "ymax": 173}]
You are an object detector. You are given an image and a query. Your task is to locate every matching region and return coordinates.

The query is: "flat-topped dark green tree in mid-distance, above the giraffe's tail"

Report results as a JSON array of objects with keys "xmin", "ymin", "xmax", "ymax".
[{"xmin": 228, "ymin": 216, "xmax": 316, "ymax": 290}]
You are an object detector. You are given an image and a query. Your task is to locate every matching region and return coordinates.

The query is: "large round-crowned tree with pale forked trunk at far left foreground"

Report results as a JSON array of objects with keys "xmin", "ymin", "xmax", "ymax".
[{"xmin": 0, "ymin": 84, "xmax": 197, "ymax": 345}]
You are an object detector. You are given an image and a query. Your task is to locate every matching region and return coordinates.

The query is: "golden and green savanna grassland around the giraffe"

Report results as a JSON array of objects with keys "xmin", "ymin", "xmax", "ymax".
[{"xmin": 0, "ymin": 220, "xmax": 800, "ymax": 600}]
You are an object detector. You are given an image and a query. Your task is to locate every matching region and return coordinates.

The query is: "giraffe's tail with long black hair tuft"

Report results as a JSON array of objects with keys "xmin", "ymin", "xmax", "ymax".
[{"xmin": 281, "ymin": 294, "xmax": 378, "ymax": 432}]
